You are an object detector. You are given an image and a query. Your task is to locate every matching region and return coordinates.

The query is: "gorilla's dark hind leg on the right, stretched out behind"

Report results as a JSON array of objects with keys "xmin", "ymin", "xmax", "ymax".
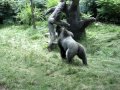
[{"xmin": 77, "ymin": 46, "xmax": 87, "ymax": 65}]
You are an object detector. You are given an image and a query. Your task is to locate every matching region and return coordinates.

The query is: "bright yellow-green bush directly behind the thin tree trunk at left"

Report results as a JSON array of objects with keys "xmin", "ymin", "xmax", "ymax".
[{"xmin": 16, "ymin": 1, "xmax": 45, "ymax": 25}]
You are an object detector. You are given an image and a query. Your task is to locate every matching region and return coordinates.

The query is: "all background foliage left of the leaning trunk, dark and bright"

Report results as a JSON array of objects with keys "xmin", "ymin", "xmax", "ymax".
[{"xmin": 0, "ymin": 0, "xmax": 46, "ymax": 24}]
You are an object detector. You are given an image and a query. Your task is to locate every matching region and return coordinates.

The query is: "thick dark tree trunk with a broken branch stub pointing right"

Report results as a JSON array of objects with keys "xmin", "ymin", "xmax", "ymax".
[{"xmin": 48, "ymin": 0, "xmax": 96, "ymax": 40}]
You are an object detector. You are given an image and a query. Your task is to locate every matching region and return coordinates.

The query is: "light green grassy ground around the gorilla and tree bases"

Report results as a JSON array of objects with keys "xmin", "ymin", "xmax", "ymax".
[{"xmin": 0, "ymin": 23, "xmax": 120, "ymax": 90}]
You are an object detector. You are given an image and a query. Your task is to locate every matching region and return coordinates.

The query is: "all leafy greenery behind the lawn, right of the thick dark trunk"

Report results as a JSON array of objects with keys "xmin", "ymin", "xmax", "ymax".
[{"xmin": 80, "ymin": 0, "xmax": 120, "ymax": 24}]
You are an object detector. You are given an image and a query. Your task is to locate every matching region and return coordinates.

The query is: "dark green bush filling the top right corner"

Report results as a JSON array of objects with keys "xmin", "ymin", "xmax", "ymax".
[{"xmin": 96, "ymin": 0, "xmax": 120, "ymax": 24}]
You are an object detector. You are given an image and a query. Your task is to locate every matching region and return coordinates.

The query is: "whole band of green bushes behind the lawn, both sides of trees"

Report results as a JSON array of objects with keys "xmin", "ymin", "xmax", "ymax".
[{"xmin": 0, "ymin": 0, "xmax": 120, "ymax": 24}]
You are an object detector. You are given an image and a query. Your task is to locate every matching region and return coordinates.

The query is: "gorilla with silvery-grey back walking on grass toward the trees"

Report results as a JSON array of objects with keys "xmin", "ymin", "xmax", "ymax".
[{"xmin": 58, "ymin": 28, "xmax": 87, "ymax": 65}]
